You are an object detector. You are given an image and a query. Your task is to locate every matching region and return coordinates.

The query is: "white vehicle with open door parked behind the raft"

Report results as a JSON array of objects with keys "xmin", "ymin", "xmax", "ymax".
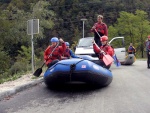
[{"xmin": 75, "ymin": 37, "xmax": 126, "ymax": 62}]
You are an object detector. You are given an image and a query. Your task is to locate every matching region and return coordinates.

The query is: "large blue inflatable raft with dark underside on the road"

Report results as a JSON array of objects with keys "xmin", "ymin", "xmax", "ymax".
[{"xmin": 44, "ymin": 58, "xmax": 113, "ymax": 87}]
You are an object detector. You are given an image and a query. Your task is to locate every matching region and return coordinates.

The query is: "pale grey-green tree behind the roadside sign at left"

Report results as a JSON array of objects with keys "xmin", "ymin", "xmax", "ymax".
[{"xmin": 0, "ymin": 0, "xmax": 55, "ymax": 75}]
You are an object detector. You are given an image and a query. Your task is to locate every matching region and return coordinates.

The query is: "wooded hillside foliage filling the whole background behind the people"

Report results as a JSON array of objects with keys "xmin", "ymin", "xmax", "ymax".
[{"xmin": 0, "ymin": 0, "xmax": 150, "ymax": 76}]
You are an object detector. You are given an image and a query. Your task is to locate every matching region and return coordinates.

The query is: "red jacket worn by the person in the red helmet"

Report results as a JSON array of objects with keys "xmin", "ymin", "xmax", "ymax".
[{"xmin": 93, "ymin": 44, "xmax": 114, "ymax": 59}]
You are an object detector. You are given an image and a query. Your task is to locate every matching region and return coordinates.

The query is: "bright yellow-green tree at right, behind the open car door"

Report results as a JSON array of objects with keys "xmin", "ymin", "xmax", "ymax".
[{"xmin": 109, "ymin": 10, "xmax": 150, "ymax": 58}]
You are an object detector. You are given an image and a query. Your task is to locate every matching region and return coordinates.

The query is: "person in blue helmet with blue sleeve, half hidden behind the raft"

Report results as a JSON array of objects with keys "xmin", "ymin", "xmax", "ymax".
[{"xmin": 62, "ymin": 42, "xmax": 80, "ymax": 59}]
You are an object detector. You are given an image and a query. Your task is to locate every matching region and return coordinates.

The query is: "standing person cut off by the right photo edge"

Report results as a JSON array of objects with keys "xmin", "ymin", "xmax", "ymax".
[{"xmin": 145, "ymin": 35, "xmax": 150, "ymax": 69}]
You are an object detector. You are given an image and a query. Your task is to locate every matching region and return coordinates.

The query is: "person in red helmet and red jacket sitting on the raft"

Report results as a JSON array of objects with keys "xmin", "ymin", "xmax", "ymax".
[{"xmin": 93, "ymin": 36, "xmax": 114, "ymax": 69}]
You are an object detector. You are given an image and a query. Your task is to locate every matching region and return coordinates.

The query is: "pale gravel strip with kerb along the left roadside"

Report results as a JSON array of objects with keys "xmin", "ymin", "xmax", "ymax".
[{"xmin": 0, "ymin": 74, "xmax": 43, "ymax": 100}]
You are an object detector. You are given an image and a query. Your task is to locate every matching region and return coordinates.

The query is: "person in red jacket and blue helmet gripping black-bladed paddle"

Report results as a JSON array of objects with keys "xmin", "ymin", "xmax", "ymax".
[{"xmin": 44, "ymin": 37, "xmax": 66, "ymax": 68}]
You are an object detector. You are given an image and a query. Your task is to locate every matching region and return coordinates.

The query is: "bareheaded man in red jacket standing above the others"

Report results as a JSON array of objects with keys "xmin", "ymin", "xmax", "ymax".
[{"xmin": 91, "ymin": 15, "xmax": 108, "ymax": 46}]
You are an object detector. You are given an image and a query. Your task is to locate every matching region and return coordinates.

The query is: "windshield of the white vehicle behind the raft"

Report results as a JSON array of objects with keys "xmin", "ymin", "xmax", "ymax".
[{"xmin": 78, "ymin": 37, "xmax": 93, "ymax": 47}]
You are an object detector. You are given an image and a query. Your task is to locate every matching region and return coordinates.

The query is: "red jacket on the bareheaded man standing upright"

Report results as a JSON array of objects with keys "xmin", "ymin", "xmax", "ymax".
[{"xmin": 91, "ymin": 22, "xmax": 108, "ymax": 36}]
